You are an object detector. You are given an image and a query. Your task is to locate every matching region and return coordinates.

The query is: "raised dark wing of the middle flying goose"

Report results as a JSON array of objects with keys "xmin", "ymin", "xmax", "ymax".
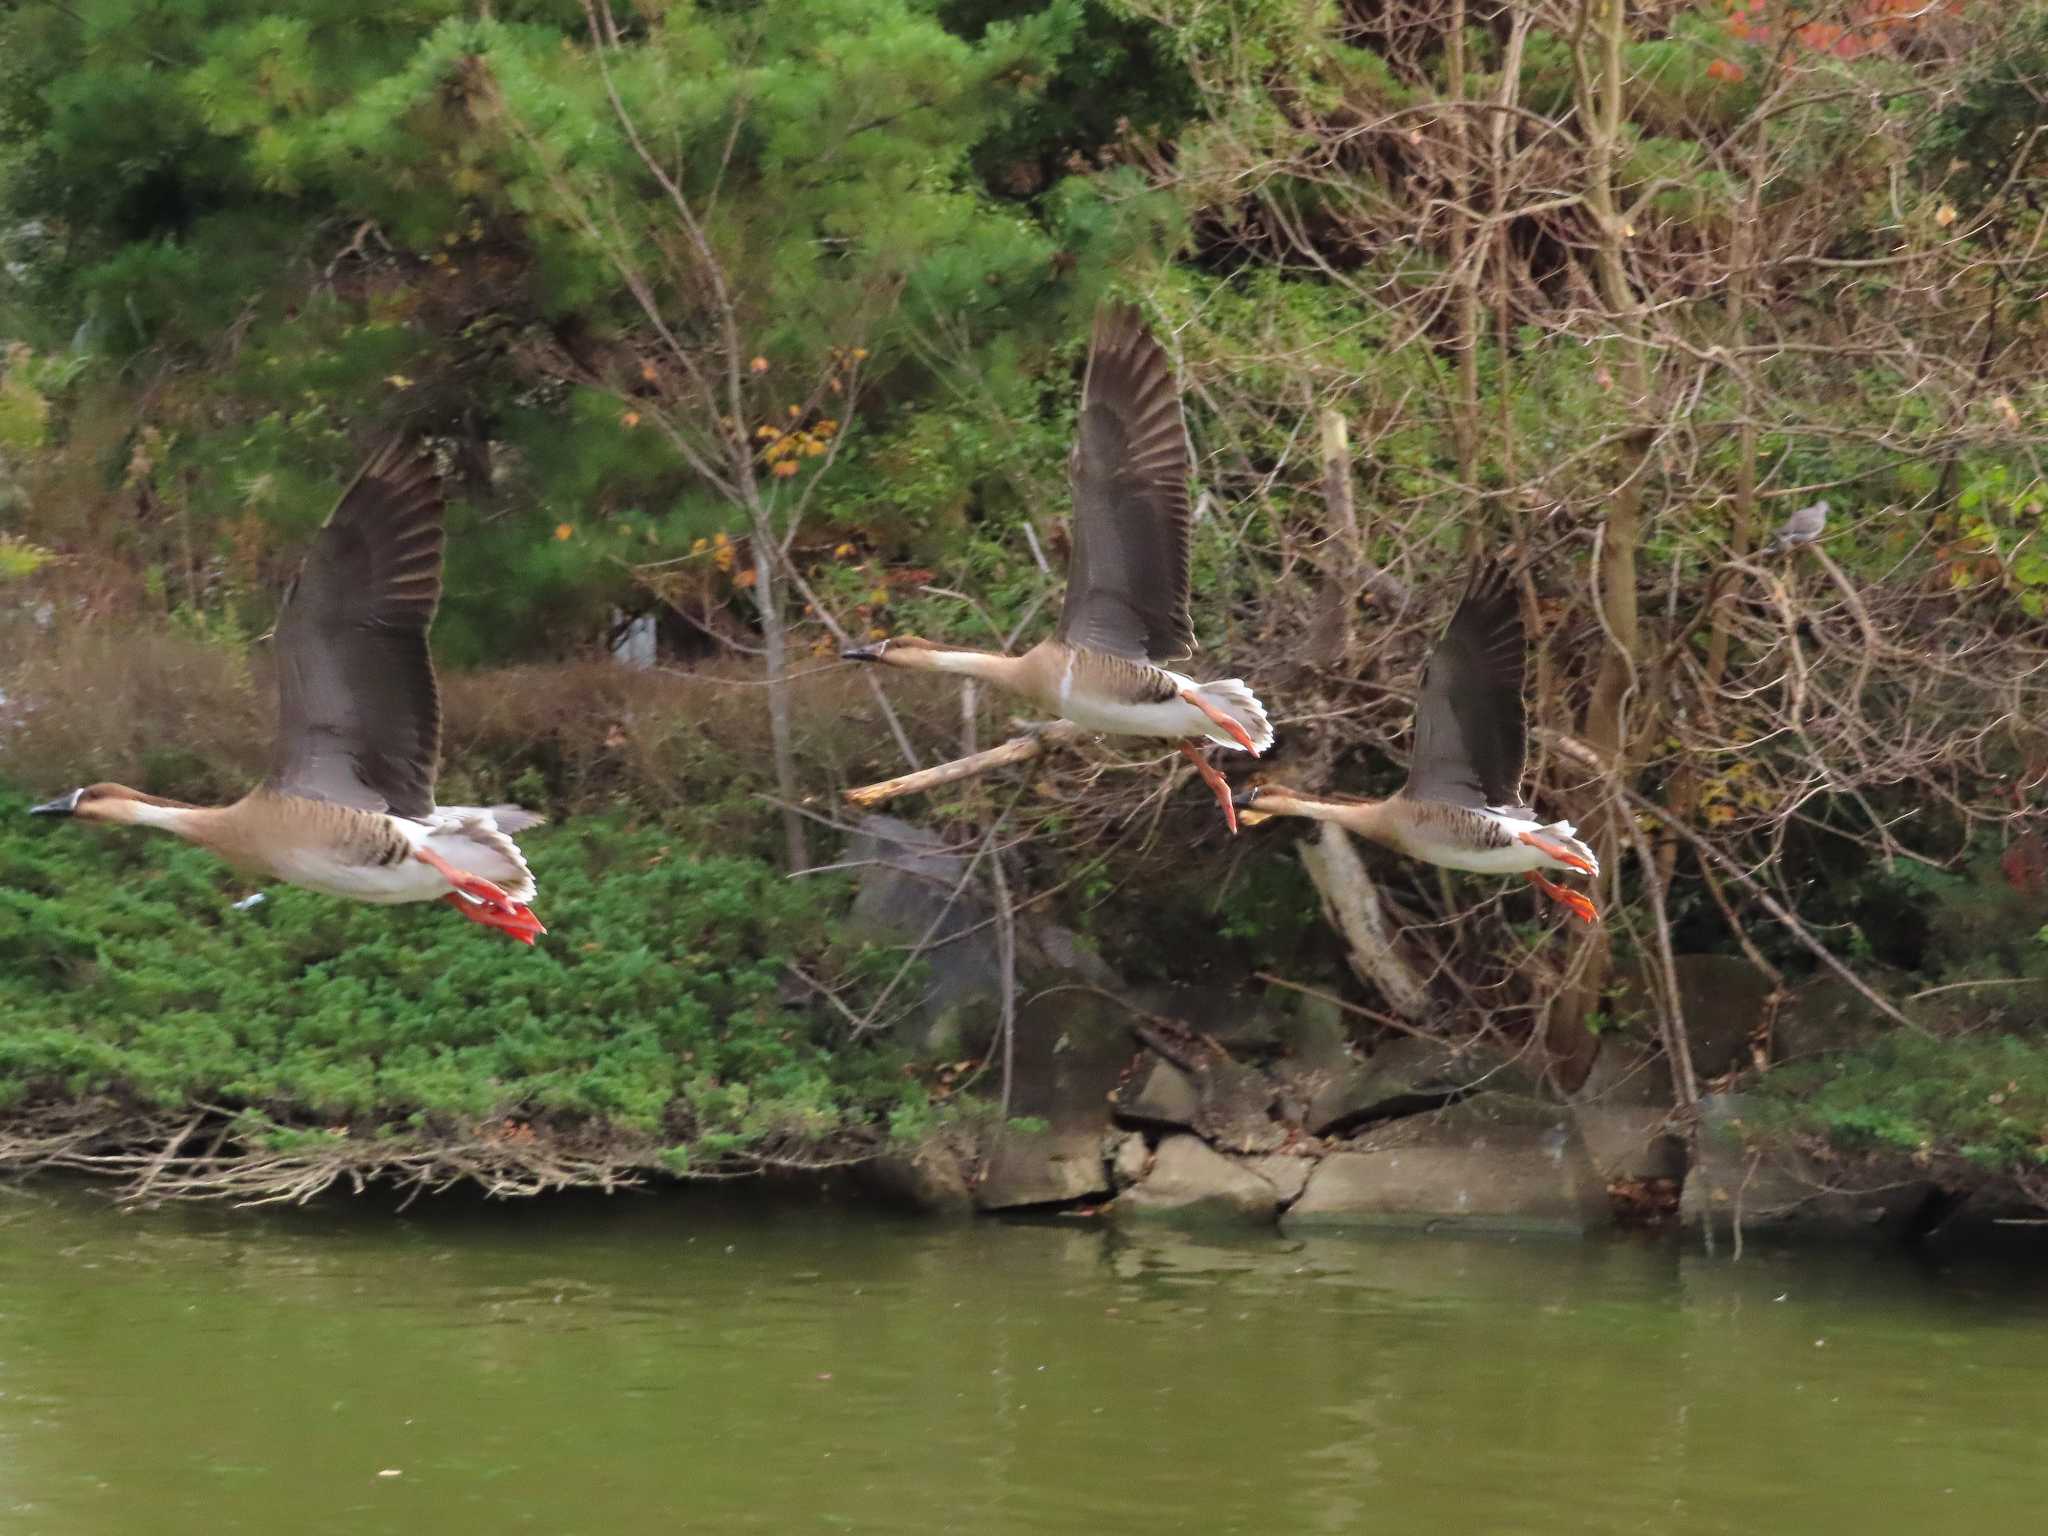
[{"xmin": 1059, "ymin": 305, "xmax": 1194, "ymax": 662}]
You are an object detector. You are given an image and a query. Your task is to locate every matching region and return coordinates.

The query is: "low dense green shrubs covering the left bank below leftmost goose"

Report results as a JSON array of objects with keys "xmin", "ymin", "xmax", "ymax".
[{"xmin": 0, "ymin": 793, "xmax": 922, "ymax": 1167}]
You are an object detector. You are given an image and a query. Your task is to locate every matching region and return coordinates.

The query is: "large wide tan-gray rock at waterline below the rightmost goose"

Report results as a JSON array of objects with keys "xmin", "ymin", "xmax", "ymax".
[{"xmin": 1286, "ymin": 1098, "xmax": 1612, "ymax": 1233}]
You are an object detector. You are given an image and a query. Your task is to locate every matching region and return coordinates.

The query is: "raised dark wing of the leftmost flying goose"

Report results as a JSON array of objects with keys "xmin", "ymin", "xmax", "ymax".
[{"xmin": 268, "ymin": 438, "xmax": 442, "ymax": 815}]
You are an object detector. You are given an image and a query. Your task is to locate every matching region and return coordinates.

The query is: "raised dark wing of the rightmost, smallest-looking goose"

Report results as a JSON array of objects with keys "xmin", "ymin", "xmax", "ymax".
[{"xmin": 1405, "ymin": 561, "xmax": 1528, "ymax": 807}]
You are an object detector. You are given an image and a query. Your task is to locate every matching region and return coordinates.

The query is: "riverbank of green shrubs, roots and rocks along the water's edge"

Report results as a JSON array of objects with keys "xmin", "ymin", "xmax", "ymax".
[{"xmin": 0, "ymin": 774, "xmax": 2048, "ymax": 1241}]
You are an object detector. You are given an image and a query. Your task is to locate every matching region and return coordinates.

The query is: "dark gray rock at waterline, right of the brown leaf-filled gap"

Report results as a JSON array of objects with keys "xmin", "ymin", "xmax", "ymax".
[{"xmin": 1679, "ymin": 1094, "xmax": 1935, "ymax": 1237}]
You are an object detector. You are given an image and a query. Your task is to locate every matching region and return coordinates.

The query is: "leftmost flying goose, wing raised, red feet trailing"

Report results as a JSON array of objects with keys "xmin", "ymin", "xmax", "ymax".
[{"xmin": 35, "ymin": 440, "xmax": 547, "ymax": 944}]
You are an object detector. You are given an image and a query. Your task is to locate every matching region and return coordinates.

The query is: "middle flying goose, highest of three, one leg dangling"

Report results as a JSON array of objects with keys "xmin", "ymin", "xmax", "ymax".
[{"xmin": 842, "ymin": 305, "xmax": 1274, "ymax": 831}]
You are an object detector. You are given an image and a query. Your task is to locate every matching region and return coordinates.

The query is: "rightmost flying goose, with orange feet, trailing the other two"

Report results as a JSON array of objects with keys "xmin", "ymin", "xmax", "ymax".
[{"xmin": 1237, "ymin": 563, "xmax": 1599, "ymax": 922}]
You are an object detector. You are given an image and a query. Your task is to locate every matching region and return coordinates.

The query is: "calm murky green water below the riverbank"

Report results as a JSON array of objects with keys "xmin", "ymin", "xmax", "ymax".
[{"xmin": 0, "ymin": 1190, "xmax": 2048, "ymax": 1536}]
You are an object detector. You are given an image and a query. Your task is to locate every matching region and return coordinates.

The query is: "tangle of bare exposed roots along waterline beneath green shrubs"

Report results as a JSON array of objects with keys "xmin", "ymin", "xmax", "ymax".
[{"xmin": 0, "ymin": 1100, "xmax": 877, "ymax": 1206}]
